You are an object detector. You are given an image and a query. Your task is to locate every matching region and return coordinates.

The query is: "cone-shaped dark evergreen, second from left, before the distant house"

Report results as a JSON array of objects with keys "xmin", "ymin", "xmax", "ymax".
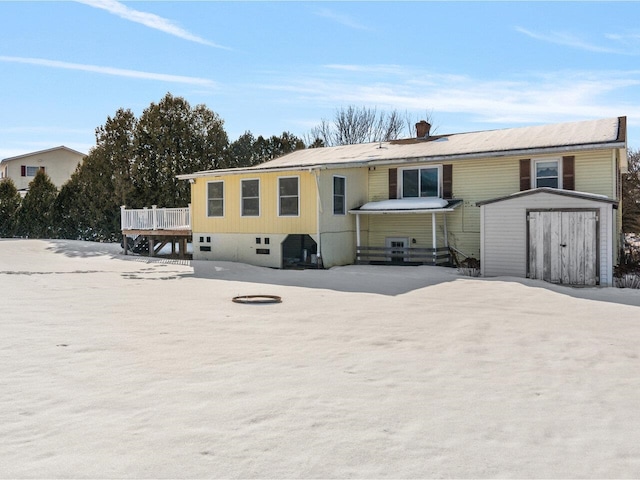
[{"xmin": 17, "ymin": 170, "xmax": 58, "ymax": 238}]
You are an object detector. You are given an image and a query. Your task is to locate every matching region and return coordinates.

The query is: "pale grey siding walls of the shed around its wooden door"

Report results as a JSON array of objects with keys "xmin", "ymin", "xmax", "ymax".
[{"xmin": 481, "ymin": 192, "xmax": 613, "ymax": 285}]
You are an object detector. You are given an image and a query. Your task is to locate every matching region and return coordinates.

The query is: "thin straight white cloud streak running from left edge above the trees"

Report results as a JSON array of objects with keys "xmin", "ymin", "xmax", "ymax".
[{"xmin": 0, "ymin": 56, "xmax": 216, "ymax": 88}]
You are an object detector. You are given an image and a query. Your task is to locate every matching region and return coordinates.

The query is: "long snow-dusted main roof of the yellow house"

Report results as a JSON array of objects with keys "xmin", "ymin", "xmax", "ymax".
[{"xmin": 178, "ymin": 117, "xmax": 626, "ymax": 179}]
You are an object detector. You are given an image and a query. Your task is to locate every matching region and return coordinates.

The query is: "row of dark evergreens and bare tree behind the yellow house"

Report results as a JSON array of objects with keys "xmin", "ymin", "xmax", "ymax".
[{"xmin": 0, "ymin": 93, "xmax": 412, "ymax": 241}]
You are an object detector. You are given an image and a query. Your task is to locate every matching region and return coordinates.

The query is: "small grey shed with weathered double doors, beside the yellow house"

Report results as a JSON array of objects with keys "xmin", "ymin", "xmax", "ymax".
[{"xmin": 477, "ymin": 187, "xmax": 618, "ymax": 286}]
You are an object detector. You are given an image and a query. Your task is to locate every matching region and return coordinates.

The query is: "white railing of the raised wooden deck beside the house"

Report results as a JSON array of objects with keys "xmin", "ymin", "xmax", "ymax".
[{"xmin": 120, "ymin": 205, "xmax": 191, "ymax": 230}]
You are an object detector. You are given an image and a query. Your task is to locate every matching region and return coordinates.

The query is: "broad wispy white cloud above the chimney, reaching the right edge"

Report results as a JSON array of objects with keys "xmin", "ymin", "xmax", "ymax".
[{"xmin": 262, "ymin": 65, "xmax": 640, "ymax": 125}]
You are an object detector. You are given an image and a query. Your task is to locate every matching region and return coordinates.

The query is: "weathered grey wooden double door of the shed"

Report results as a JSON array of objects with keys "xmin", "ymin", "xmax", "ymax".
[{"xmin": 528, "ymin": 210, "xmax": 598, "ymax": 285}]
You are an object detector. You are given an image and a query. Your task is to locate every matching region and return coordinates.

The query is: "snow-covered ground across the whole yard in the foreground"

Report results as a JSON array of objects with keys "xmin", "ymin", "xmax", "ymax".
[{"xmin": 0, "ymin": 240, "xmax": 640, "ymax": 478}]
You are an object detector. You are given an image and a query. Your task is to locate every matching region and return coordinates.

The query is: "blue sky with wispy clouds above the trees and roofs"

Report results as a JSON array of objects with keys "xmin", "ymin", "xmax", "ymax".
[{"xmin": 0, "ymin": 0, "xmax": 640, "ymax": 158}]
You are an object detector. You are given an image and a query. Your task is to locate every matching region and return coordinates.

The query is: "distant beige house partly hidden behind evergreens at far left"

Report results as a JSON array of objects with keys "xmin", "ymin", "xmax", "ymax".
[{"xmin": 0, "ymin": 146, "xmax": 86, "ymax": 195}]
